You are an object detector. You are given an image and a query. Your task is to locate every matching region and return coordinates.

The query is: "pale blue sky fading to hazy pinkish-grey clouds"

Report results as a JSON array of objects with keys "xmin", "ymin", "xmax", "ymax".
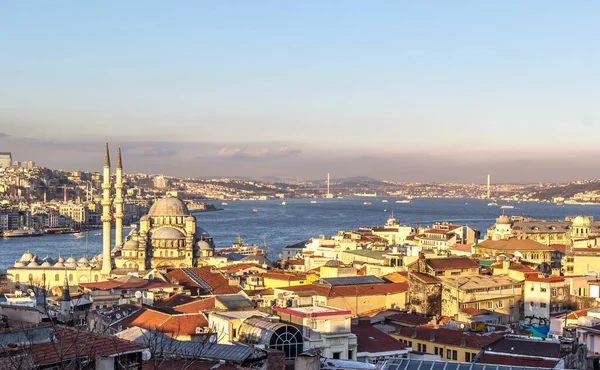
[{"xmin": 0, "ymin": 0, "xmax": 600, "ymax": 183}]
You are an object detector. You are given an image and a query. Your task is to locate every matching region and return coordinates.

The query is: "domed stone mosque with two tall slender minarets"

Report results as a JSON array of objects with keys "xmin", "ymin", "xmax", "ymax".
[{"xmin": 7, "ymin": 142, "xmax": 214, "ymax": 289}]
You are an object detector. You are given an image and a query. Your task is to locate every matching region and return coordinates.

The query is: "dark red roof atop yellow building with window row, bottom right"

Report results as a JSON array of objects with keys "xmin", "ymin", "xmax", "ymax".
[{"xmin": 396, "ymin": 325, "xmax": 505, "ymax": 349}]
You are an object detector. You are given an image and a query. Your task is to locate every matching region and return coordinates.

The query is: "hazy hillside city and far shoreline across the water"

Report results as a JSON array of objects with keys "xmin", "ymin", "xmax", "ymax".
[{"xmin": 0, "ymin": 148, "xmax": 600, "ymax": 231}]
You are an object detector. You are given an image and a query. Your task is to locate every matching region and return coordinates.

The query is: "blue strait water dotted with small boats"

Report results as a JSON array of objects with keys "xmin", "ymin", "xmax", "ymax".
[{"xmin": 0, "ymin": 197, "xmax": 600, "ymax": 268}]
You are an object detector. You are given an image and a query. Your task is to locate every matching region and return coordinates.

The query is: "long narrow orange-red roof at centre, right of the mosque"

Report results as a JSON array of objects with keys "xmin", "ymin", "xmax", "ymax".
[{"xmin": 278, "ymin": 283, "xmax": 408, "ymax": 298}]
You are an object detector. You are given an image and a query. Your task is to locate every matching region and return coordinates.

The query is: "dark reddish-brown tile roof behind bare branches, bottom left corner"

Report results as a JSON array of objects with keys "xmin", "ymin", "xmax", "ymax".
[{"xmin": 28, "ymin": 325, "xmax": 147, "ymax": 366}]
